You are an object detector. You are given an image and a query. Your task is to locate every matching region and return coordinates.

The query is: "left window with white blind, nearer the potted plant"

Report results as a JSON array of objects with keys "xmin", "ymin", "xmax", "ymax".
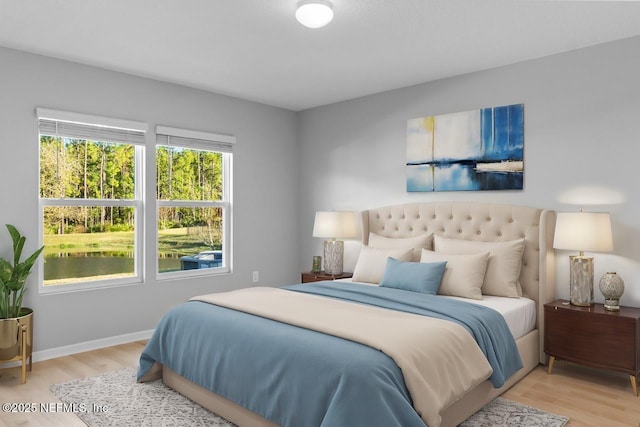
[{"xmin": 37, "ymin": 108, "xmax": 147, "ymax": 292}]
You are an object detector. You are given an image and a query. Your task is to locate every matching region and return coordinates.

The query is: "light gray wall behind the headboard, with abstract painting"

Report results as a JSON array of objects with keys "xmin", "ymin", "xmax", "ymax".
[{"xmin": 298, "ymin": 37, "xmax": 640, "ymax": 306}]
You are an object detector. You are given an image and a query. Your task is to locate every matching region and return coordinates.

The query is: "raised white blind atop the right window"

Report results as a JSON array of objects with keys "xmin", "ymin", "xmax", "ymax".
[{"xmin": 156, "ymin": 126, "xmax": 236, "ymax": 153}]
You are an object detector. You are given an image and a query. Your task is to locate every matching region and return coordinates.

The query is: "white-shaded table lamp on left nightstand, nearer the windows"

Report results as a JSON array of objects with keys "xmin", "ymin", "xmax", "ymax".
[{"xmin": 313, "ymin": 212, "xmax": 358, "ymax": 275}]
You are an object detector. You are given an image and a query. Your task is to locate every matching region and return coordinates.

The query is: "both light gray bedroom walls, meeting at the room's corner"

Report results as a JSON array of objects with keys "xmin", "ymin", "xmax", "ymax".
[{"xmin": 0, "ymin": 33, "xmax": 640, "ymax": 351}]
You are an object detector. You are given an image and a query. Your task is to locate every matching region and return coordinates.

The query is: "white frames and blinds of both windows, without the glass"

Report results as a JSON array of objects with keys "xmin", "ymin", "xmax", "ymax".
[{"xmin": 36, "ymin": 108, "xmax": 236, "ymax": 294}]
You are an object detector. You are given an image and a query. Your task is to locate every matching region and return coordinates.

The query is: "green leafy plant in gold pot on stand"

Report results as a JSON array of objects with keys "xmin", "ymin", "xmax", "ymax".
[{"xmin": 0, "ymin": 224, "xmax": 44, "ymax": 364}]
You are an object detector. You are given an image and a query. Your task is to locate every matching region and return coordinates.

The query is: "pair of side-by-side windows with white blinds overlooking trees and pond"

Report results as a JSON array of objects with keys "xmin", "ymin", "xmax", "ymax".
[{"xmin": 36, "ymin": 108, "xmax": 235, "ymax": 293}]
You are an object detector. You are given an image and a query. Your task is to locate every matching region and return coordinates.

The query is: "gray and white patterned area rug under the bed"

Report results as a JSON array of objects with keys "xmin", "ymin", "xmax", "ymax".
[{"xmin": 50, "ymin": 368, "xmax": 568, "ymax": 427}]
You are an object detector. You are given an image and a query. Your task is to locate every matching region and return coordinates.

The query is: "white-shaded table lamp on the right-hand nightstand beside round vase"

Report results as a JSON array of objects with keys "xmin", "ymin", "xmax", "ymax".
[{"xmin": 553, "ymin": 211, "xmax": 613, "ymax": 306}]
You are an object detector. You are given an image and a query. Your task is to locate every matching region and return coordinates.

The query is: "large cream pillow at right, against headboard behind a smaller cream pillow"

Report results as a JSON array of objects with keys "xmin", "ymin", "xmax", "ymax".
[{"xmin": 434, "ymin": 236, "xmax": 524, "ymax": 298}]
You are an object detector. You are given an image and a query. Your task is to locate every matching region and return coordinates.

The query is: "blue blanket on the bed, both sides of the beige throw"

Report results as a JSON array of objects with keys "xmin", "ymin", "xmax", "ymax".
[{"xmin": 138, "ymin": 282, "xmax": 521, "ymax": 427}]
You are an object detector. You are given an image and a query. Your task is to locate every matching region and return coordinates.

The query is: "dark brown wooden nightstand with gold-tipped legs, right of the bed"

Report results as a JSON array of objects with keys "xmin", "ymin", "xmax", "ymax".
[{"xmin": 544, "ymin": 300, "xmax": 640, "ymax": 396}]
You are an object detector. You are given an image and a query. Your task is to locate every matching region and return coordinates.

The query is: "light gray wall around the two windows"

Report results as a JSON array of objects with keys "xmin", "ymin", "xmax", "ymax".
[{"xmin": 0, "ymin": 48, "xmax": 299, "ymax": 351}]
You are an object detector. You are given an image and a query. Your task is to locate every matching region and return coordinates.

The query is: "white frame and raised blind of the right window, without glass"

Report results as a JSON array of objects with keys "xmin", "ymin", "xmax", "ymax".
[{"xmin": 153, "ymin": 125, "xmax": 236, "ymax": 281}]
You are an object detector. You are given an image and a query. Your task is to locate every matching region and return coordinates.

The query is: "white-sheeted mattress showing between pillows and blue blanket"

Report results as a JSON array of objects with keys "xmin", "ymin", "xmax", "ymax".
[{"xmin": 339, "ymin": 279, "xmax": 536, "ymax": 340}]
